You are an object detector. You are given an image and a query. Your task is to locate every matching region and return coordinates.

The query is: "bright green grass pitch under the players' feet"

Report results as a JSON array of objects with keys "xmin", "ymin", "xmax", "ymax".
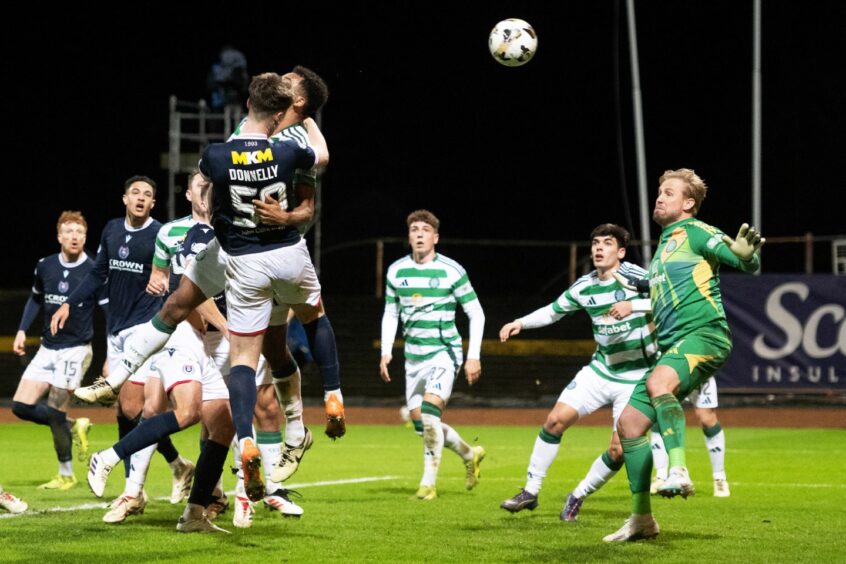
[{"xmin": 0, "ymin": 423, "xmax": 846, "ymax": 563}]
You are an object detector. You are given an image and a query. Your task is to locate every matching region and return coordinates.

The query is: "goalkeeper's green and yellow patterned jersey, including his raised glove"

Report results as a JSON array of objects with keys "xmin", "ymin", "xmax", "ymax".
[{"xmin": 649, "ymin": 217, "xmax": 759, "ymax": 351}]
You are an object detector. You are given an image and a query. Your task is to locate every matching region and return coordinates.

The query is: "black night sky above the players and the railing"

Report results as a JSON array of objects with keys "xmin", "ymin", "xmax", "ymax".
[{"xmin": 2, "ymin": 0, "xmax": 846, "ymax": 292}]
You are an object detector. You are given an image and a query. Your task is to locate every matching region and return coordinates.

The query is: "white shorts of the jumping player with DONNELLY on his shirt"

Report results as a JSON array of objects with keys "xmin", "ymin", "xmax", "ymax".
[{"xmin": 226, "ymin": 239, "xmax": 320, "ymax": 335}]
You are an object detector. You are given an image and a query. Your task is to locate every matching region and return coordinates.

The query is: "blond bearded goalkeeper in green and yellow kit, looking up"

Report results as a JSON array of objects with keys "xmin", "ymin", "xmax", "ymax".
[{"xmin": 604, "ymin": 168, "xmax": 764, "ymax": 542}]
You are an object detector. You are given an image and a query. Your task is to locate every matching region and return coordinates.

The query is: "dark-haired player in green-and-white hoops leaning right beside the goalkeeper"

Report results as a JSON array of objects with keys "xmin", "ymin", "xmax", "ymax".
[{"xmin": 499, "ymin": 223, "xmax": 658, "ymax": 521}]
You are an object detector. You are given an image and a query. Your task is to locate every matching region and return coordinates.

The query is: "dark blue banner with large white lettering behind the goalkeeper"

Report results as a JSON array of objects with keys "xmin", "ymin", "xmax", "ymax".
[{"xmin": 717, "ymin": 274, "xmax": 846, "ymax": 392}]
